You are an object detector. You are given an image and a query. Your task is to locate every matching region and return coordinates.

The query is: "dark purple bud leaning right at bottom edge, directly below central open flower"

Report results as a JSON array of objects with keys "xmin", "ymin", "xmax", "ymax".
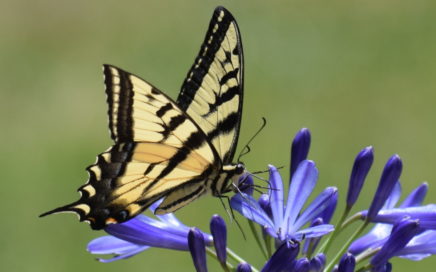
[{"xmin": 262, "ymin": 242, "xmax": 300, "ymax": 272}]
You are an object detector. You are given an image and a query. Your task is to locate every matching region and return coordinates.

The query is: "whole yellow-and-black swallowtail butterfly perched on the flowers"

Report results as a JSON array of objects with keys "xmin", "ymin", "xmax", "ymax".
[{"xmin": 42, "ymin": 7, "xmax": 244, "ymax": 229}]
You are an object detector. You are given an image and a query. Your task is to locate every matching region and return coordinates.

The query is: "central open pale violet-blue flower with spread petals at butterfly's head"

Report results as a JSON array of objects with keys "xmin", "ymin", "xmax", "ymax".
[{"xmin": 231, "ymin": 160, "xmax": 337, "ymax": 241}]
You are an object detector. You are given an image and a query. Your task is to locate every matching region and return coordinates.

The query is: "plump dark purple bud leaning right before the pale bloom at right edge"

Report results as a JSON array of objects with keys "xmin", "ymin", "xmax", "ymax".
[{"xmin": 371, "ymin": 219, "xmax": 419, "ymax": 267}]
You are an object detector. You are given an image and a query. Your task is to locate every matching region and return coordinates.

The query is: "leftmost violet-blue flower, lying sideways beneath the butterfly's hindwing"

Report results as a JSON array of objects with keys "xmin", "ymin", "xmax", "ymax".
[{"xmin": 87, "ymin": 201, "xmax": 212, "ymax": 262}]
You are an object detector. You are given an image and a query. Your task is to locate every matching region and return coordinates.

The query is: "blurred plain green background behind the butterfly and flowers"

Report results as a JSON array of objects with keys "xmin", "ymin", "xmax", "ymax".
[{"xmin": 0, "ymin": 0, "xmax": 436, "ymax": 271}]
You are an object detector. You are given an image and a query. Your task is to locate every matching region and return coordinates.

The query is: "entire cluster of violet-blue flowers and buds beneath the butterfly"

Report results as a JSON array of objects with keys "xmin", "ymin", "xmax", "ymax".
[{"xmin": 88, "ymin": 129, "xmax": 436, "ymax": 272}]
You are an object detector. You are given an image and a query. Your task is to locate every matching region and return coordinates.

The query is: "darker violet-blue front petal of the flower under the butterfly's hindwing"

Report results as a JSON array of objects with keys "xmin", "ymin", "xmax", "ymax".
[{"xmin": 105, "ymin": 216, "xmax": 188, "ymax": 250}]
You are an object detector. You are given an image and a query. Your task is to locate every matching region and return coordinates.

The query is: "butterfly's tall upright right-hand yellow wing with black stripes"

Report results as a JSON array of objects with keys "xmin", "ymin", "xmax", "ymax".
[{"xmin": 177, "ymin": 7, "xmax": 243, "ymax": 164}]
